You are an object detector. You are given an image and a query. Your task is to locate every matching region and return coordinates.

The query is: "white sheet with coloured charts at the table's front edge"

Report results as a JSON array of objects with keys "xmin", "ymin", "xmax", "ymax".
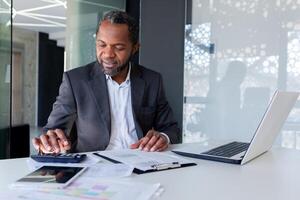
[{"xmin": 0, "ymin": 177, "xmax": 161, "ymax": 200}]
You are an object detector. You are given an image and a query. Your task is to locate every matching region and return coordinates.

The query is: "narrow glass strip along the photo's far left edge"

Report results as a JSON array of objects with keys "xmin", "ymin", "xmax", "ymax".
[{"xmin": 0, "ymin": 0, "xmax": 11, "ymax": 158}]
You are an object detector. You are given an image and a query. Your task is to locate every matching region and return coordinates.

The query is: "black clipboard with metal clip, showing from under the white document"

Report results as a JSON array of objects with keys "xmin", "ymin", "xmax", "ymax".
[{"xmin": 93, "ymin": 152, "xmax": 197, "ymax": 174}]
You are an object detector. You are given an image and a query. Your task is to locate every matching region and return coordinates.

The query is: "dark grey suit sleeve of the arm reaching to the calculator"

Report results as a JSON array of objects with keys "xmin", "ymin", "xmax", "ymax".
[{"xmin": 43, "ymin": 73, "xmax": 76, "ymax": 133}]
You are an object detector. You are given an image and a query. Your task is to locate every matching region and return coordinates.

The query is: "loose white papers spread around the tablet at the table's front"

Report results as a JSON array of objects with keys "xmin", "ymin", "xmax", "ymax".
[{"xmin": 0, "ymin": 151, "xmax": 162, "ymax": 200}]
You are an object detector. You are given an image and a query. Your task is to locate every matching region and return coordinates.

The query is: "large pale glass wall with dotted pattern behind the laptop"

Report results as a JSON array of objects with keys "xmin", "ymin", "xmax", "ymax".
[{"xmin": 183, "ymin": 0, "xmax": 300, "ymax": 149}]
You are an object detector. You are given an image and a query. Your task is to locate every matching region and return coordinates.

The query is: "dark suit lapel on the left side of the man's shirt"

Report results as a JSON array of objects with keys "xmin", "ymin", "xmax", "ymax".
[{"xmin": 88, "ymin": 62, "xmax": 111, "ymax": 134}]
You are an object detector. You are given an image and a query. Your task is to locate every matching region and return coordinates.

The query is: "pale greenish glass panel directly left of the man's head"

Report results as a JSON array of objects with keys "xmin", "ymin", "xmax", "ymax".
[{"xmin": 66, "ymin": 0, "xmax": 126, "ymax": 69}]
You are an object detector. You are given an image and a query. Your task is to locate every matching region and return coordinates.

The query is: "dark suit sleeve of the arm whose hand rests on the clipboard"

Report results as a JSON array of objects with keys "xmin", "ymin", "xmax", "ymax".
[{"xmin": 154, "ymin": 75, "xmax": 181, "ymax": 144}]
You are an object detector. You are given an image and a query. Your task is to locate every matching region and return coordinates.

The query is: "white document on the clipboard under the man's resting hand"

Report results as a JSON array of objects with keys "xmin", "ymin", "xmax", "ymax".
[{"xmin": 98, "ymin": 149, "xmax": 191, "ymax": 171}]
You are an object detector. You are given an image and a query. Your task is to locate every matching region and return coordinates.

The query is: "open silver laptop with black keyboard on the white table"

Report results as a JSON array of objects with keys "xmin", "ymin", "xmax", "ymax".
[{"xmin": 172, "ymin": 90, "xmax": 299, "ymax": 165}]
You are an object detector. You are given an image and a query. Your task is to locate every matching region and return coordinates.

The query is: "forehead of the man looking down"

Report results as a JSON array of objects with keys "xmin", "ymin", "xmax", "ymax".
[{"xmin": 97, "ymin": 20, "xmax": 130, "ymax": 42}]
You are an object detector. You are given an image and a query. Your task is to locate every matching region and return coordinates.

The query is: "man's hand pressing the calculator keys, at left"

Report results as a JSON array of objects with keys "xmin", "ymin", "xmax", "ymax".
[{"xmin": 32, "ymin": 129, "xmax": 71, "ymax": 153}]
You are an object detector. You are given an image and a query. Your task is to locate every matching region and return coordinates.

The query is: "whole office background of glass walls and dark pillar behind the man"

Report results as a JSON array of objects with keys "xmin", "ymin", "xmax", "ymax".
[{"xmin": 0, "ymin": 0, "xmax": 300, "ymax": 158}]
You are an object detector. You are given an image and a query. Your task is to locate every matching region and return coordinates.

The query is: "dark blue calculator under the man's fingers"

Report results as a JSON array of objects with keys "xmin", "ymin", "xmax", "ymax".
[{"xmin": 30, "ymin": 153, "xmax": 87, "ymax": 163}]
